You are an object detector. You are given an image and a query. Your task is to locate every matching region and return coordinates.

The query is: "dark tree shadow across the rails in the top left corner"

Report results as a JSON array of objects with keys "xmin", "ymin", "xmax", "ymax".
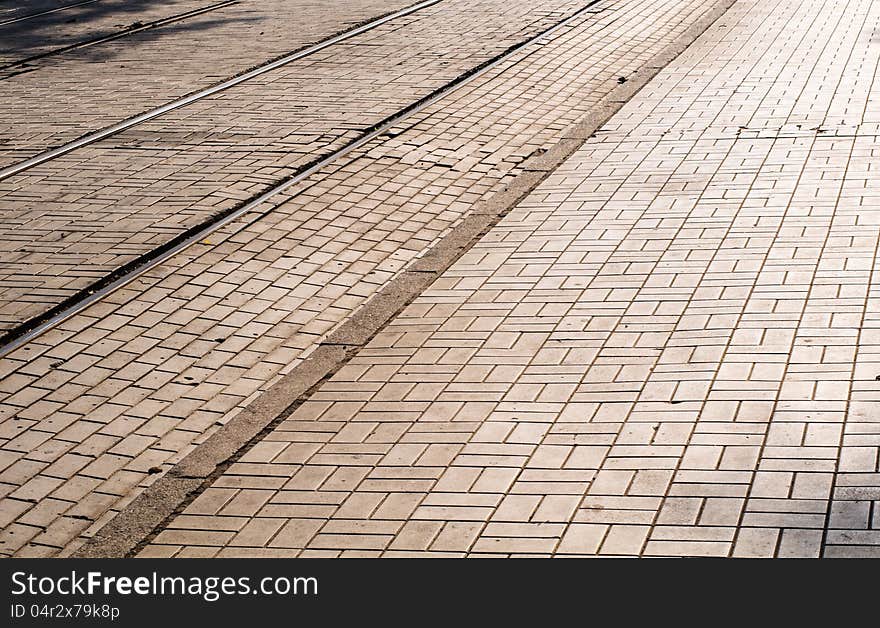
[{"xmin": 0, "ymin": 0, "xmax": 265, "ymax": 67}]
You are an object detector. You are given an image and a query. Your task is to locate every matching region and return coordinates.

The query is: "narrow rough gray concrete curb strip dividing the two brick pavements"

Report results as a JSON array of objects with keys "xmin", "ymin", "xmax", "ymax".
[{"xmin": 72, "ymin": 0, "xmax": 736, "ymax": 558}]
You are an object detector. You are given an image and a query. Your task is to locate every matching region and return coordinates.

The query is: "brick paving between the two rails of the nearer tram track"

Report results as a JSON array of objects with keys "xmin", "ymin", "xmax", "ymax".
[{"xmin": 0, "ymin": 0, "xmax": 600, "ymax": 330}]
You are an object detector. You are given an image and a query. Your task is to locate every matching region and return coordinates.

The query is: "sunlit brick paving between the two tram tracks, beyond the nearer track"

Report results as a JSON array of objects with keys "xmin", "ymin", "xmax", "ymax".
[{"xmin": 0, "ymin": 0, "xmax": 413, "ymax": 167}]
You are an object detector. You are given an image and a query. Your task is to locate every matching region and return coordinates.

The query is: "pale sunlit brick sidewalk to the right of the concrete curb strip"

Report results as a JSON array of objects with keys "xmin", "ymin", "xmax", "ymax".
[{"xmin": 141, "ymin": 0, "xmax": 880, "ymax": 557}]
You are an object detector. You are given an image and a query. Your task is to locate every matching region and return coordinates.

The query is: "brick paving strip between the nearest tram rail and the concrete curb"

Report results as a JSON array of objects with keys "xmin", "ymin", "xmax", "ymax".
[{"xmin": 0, "ymin": 0, "xmax": 709, "ymax": 555}]
